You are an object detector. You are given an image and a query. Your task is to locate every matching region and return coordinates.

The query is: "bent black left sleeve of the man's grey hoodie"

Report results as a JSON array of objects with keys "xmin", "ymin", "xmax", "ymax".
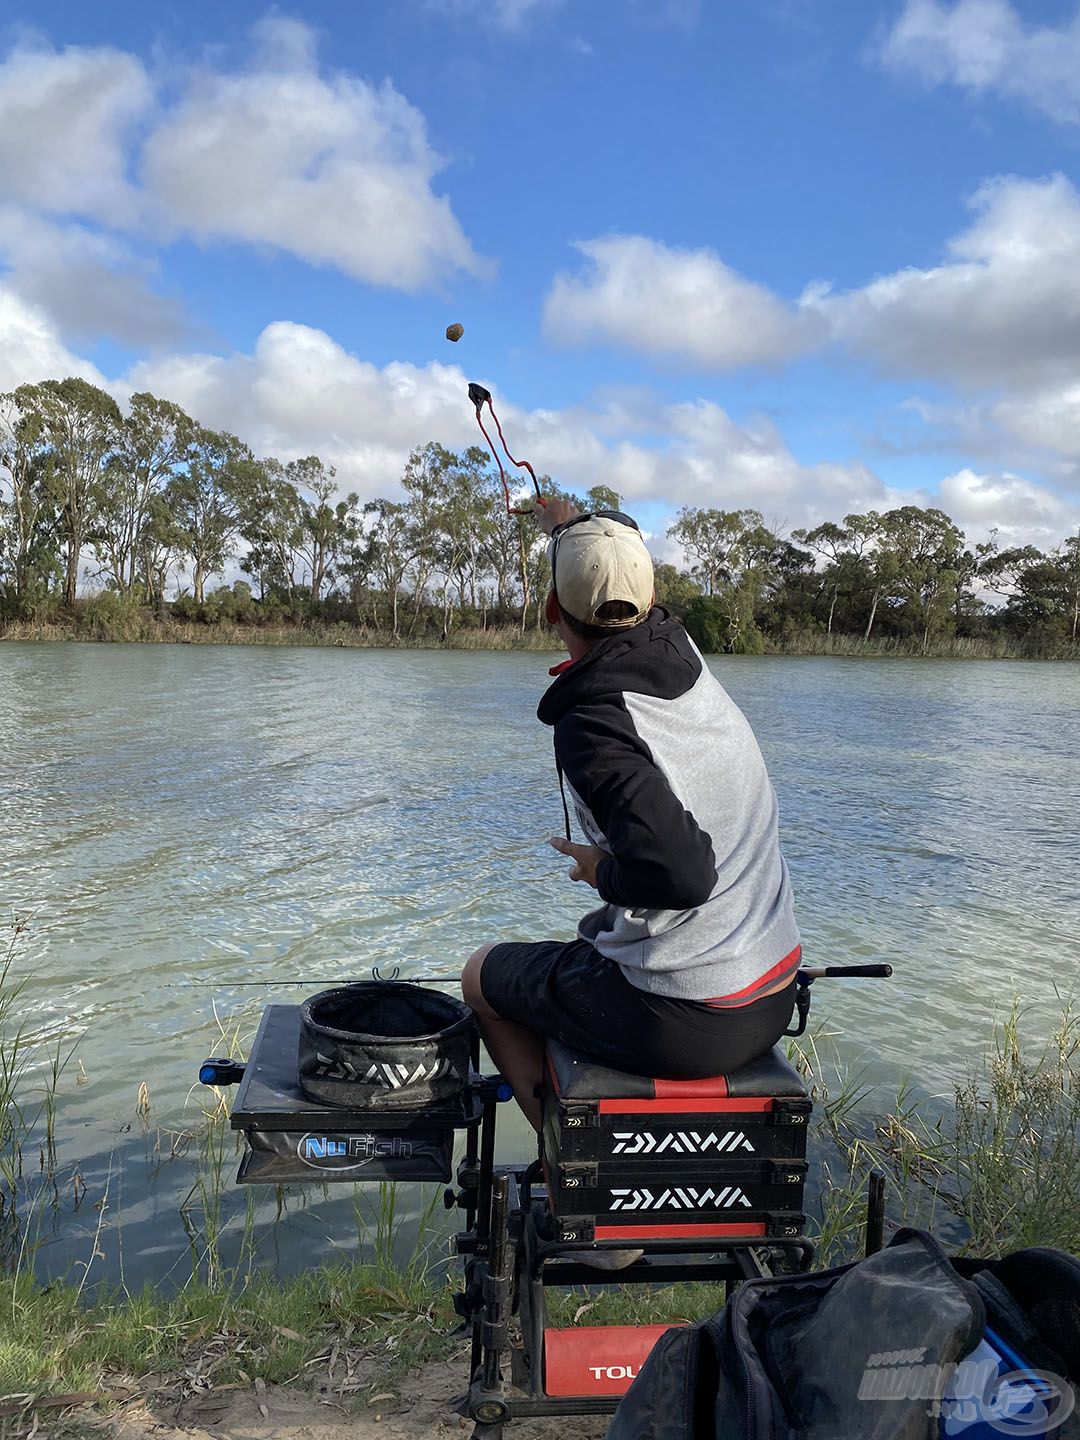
[{"xmin": 554, "ymin": 703, "xmax": 717, "ymax": 910}]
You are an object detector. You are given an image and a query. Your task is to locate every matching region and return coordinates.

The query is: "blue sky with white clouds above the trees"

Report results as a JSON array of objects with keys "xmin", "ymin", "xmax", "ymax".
[{"xmin": 0, "ymin": 0, "xmax": 1080, "ymax": 546}]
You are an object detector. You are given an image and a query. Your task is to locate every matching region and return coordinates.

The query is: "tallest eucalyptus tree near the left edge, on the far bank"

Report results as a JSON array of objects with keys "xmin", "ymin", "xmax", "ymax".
[{"xmin": 14, "ymin": 377, "xmax": 122, "ymax": 605}]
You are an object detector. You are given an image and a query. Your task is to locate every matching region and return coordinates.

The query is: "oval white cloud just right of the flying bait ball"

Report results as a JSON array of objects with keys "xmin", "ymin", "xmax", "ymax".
[{"xmin": 544, "ymin": 235, "xmax": 825, "ymax": 370}]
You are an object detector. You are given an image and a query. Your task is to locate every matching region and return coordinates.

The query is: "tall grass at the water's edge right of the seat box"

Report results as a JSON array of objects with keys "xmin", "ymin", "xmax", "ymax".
[{"xmin": 792, "ymin": 1002, "xmax": 1080, "ymax": 1264}]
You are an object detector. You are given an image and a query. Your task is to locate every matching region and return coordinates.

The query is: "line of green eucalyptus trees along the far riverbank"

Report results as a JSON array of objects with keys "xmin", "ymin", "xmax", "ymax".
[{"xmin": 0, "ymin": 379, "xmax": 1080, "ymax": 654}]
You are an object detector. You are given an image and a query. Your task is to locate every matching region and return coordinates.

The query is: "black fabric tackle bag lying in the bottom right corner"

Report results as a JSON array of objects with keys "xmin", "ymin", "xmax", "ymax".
[{"xmin": 608, "ymin": 1230, "xmax": 1080, "ymax": 1440}]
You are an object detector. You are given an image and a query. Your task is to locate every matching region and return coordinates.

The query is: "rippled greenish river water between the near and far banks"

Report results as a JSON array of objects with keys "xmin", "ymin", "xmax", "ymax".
[{"xmin": 0, "ymin": 644, "xmax": 1080, "ymax": 1284}]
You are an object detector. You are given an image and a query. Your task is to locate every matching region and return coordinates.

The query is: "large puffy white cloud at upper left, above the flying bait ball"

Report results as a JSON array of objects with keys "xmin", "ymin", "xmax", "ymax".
[{"xmin": 141, "ymin": 20, "xmax": 482, "ymax": 289}]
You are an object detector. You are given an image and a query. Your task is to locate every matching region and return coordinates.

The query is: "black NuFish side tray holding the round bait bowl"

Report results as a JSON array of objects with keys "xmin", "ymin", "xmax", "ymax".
[{"xmin": 230, "ymin": 1005, "xmax": 480, "ymax": 1185}]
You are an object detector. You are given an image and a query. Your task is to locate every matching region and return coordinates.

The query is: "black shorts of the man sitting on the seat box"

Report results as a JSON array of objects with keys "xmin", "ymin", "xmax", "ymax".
[{"xmin": 480, "ymin": 940, "xmax": 795, "ymax": 1080}]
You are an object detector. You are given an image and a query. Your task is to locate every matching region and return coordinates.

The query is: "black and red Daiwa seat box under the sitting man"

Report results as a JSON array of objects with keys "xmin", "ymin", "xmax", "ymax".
[{"xmin": 541, "ymin": 1041, "xmax": 812, "ymax": 1241}]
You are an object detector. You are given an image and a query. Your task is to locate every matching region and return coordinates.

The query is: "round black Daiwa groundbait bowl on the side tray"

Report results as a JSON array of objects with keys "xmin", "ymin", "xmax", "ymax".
[{"xmin": 300, "ymin": 981, "xmax": 475, "ymax": 1113}]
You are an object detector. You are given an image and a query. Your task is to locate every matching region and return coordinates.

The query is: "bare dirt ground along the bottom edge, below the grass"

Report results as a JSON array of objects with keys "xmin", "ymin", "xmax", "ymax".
[{"xmin": 84, "ymin": 1356, "xmax": 609, "ymax": 1440}]
